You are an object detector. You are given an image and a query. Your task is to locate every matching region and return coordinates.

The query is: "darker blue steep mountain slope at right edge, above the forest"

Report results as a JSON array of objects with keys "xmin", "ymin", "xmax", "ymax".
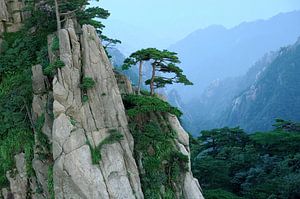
[{"xmin": 221, "ymin": 40, "xmax": 300, "ymax": 131}]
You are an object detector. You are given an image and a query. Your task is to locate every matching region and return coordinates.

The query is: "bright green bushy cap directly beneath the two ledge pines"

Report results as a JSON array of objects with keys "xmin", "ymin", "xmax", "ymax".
[{"xmin": 123, "ymin": 95, "xmax": 182, "ymax": 117}]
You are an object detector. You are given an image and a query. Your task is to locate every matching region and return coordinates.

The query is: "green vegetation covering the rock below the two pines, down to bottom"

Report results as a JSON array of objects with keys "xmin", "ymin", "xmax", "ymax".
[{"xmin": 123, "ymin": 92, "xmax": 189, "ymax": 199}]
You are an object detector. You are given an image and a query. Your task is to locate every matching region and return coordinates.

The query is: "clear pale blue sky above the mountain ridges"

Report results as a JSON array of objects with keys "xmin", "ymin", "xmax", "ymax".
[{"xmin": 92, "ymin": 0, "xmax": 300, "ymax": 54}]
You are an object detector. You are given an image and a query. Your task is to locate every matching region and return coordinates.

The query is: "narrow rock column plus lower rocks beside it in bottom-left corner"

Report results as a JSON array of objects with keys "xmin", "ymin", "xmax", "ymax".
[{"xmin": 2, "ymin": 65, "xmax": 52, "ymax": 199}]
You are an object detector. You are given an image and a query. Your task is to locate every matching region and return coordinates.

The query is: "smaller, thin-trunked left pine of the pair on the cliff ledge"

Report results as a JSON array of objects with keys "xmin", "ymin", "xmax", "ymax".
[{"xmin": 122, "ymin": 49, "xmax": 151, "ymax": 94}]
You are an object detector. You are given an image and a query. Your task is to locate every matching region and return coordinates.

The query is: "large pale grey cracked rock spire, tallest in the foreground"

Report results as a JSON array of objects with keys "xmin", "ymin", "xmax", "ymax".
[{"xmin": 53, "ymin": 21, "xmax": 143, "ymax": 198}]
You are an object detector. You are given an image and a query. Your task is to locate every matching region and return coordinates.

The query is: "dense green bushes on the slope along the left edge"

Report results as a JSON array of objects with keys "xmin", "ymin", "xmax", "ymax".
[{"xmin": 0, "ymin": 27, "xmax": 47, "ymax": 187}]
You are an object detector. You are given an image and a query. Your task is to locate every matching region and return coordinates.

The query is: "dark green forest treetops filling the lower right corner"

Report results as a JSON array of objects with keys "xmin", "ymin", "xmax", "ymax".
[{"xmin": 191, "ymin": 120, "xmax": 300, "ymax": 199}]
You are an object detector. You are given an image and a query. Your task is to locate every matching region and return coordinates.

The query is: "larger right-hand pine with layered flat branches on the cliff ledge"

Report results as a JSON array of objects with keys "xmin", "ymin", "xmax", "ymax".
[{"xmin": 145, "ymin": 48, "xmax": 193, "ymax": 95}]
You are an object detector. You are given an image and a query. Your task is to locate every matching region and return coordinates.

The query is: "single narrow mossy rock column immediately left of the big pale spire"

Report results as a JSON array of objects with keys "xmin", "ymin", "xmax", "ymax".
[{"xmin": 32, "ymin": 65, "xmax": 53, "ymax": 198}]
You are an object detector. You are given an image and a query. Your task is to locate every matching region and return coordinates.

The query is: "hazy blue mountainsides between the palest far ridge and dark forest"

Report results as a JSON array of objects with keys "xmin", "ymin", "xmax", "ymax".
[{"xmin": 181, "ymin": 39, "xmax": 300, "ymax": 134}]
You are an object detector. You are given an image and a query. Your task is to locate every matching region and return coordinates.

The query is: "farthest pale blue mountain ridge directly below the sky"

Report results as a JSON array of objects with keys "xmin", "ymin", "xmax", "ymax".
[{"xmin": 170, "ymin": 11, "xmax": 300, "ymax": 102}]
